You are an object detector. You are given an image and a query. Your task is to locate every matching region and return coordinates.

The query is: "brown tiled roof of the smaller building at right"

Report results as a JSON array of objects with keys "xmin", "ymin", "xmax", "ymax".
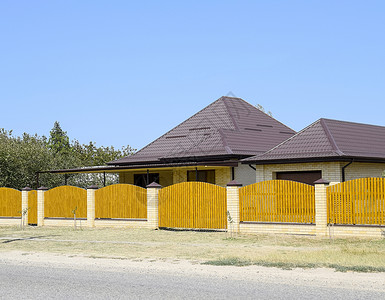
[{"xmin": 243, "ymin": 119, "xmax": 385, "ymax": 163}]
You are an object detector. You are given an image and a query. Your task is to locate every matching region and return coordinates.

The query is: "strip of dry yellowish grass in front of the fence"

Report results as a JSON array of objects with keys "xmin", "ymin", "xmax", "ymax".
[{"xmin": 0, "ymin": 227, "xmax": 385, "ymax": 271}]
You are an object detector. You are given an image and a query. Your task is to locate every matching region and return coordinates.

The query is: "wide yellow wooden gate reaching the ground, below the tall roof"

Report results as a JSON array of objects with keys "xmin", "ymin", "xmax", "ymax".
[{"xmin": 159, "ymin": 182, "xmax": 227, "ymax": 229}]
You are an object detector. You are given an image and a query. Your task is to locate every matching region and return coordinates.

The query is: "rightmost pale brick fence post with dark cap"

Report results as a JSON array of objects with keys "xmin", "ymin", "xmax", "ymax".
[{"xmin": 314, "ymin": 178, "xmax": 329, "ymax": 236}]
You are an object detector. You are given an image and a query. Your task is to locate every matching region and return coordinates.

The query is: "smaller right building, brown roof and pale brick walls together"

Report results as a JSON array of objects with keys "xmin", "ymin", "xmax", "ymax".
[{"xmin": 242, "ymin": 119, "xmax": 385, "ymax": 184}]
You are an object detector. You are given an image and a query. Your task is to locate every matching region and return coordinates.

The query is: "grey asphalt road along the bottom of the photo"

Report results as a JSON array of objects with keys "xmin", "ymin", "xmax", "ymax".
[{"xmin": 0, "ymin": 262, "xmax": 385, "ymax": 299}]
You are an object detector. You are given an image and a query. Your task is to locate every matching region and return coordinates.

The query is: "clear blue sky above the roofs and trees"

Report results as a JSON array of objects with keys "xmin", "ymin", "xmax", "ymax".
[{"xmin": 0, "ymin": 0, "xmax": 385, "ymax": 148}]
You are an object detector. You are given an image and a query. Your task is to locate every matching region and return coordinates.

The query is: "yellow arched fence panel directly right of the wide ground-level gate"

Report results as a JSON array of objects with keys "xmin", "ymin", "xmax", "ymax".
[{"xmin": 239, "ymin": 180, "xmax": 315, "ymax": 223}]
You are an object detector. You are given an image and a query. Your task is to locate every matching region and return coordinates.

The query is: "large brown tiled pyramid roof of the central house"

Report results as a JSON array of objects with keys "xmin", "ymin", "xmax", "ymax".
[{"xmin": 108, "ymin": 97, "xmax": 295, "ymax": 165}]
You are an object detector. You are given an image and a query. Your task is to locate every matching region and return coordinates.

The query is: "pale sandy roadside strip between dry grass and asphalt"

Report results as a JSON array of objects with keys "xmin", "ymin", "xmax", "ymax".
[{"xmin": 0, "ymin": 251, "xmax": 385, "ymax": 292}]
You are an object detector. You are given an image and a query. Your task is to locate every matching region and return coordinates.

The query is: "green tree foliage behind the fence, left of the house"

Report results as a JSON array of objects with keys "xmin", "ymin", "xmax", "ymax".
[{"xmin": 0, "ymin": 122, "xmax": 135, "ymax": 189}]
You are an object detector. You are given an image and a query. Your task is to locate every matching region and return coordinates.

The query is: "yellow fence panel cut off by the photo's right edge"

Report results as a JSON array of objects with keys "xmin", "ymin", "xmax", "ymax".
[{"xmin": 326, "ymin": 178, "xmax": 385, "ymax": 225}]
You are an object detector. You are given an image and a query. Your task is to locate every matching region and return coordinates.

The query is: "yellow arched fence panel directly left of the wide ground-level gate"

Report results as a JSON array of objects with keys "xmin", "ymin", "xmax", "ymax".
[{"xmin": 95, "ymin": 184, "xmax": 147, "ymax": 219}]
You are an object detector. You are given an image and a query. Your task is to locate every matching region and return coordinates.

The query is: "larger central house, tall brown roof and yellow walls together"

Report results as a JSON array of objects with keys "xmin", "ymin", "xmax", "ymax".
[{"xmin": 105, "ymin": 97, "xmax": 295, "ymax": 187}]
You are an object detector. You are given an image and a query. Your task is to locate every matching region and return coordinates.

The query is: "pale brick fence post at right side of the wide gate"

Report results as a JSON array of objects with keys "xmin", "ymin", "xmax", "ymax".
[{"xmin": 226, "ymin": 180, "xmax": 242, "ymax": 232}]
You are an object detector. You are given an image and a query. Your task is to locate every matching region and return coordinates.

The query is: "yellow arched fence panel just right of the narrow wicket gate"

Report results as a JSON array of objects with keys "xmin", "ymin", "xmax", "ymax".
[{"xmin": 44, "ymin": 185, "xmax": 87, "ymax": 218}]
